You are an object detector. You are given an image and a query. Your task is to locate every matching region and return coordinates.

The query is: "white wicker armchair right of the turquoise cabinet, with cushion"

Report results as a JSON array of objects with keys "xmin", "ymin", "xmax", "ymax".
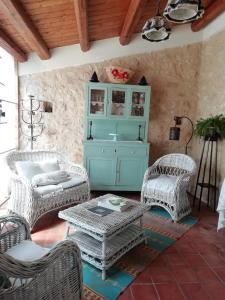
[{"xmin": 141, "ymin": 154, "xmax": 196, "ymax": 222}]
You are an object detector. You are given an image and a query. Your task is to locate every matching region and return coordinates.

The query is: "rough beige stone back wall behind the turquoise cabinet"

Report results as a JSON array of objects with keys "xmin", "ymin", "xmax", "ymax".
[{"xmin": 20, "ymin": 44, "xmax": 201, "ymax": 163}]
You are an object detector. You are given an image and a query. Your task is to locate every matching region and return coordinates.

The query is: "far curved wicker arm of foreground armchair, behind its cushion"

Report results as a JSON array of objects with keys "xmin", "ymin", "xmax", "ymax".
[{"xmin": 0, "ymin": 215, "xmax": 31, "ymax": 252}]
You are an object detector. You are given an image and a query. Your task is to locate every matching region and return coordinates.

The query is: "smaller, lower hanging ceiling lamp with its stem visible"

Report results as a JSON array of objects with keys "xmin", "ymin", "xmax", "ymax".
[{"xmin": 142, "ymin": 0, "xmax": 171, "ymax": 42}]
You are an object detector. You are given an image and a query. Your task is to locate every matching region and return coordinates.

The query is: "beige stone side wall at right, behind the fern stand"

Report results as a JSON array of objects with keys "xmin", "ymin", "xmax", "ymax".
[{"xmin": 192, "ymin": 31, "xmax": 225, "ymax": 192}]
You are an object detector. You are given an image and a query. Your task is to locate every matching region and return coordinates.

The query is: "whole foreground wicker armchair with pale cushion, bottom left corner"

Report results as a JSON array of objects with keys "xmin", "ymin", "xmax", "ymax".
[{"xmin": 0, "ymin": 216, "xmax": 82, "ymax": 300}]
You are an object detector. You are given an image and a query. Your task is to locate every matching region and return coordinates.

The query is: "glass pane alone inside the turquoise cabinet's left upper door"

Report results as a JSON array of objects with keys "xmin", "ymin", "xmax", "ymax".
[{"xmin": 90, "ymin": 89, "xmax": 105, "ymax": 115}]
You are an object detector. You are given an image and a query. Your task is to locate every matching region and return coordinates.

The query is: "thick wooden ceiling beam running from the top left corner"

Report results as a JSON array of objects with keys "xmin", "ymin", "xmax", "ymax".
[{"xmin": 0, "ymin": 0, "xmax": 50, "ymax": 59}]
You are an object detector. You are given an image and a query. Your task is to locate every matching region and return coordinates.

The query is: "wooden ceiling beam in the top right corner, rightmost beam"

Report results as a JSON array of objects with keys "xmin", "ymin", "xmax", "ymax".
[{"xmin": 191, "ymin": 0, "xmax": 225, "ymax": 32}]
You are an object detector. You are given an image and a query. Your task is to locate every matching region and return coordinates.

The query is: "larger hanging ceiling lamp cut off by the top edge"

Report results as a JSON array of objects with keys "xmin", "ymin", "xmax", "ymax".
[{"xmin": 163, "ymin": 0, "xmax": 204, "ymax": 23}]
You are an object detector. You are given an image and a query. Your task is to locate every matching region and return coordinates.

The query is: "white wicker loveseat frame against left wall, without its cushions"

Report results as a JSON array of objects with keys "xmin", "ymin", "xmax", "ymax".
[{"xmin": 6, "ymin": 151, "xmax": 90, "ymax": 229}]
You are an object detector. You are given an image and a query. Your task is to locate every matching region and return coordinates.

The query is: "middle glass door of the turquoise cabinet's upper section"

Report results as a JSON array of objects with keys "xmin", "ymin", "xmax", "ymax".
[{"xmin": 110, "ymin": 89, "xmax": 126, "ymax": 117}]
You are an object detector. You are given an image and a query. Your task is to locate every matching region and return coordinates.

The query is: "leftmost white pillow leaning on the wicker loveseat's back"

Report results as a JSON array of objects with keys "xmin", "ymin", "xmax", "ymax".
[{"xmin": 15, "ymin": 161, "xmax": 44, "ymax": 180}]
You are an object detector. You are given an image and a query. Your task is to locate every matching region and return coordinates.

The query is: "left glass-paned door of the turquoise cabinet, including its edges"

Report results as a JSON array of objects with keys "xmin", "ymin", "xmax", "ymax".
[{"xmin": 89, "ymin": 88, "xmax": 106, "ymax": 116}]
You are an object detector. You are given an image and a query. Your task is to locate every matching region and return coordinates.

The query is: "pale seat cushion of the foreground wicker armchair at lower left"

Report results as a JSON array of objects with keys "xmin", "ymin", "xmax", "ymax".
[{"xmin": 6, "ymin": 240, "xmax": 49, "ymax": 262}]
